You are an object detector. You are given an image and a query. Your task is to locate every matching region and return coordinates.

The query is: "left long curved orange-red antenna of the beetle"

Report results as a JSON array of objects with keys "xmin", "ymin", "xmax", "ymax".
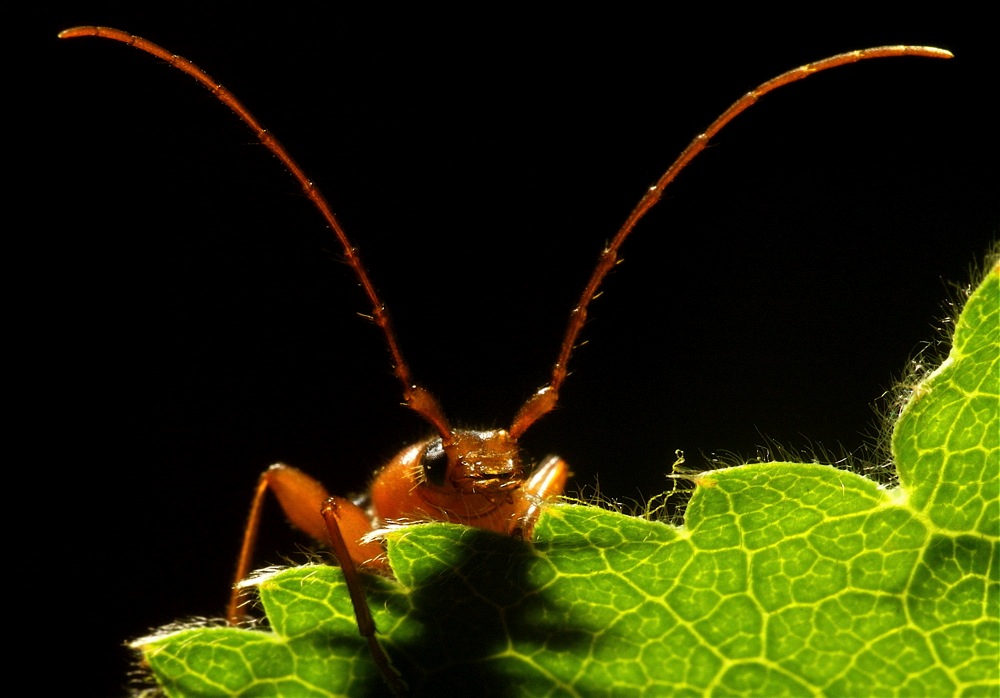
[{"xmin": 59, "ymin": 26, "xmax": 452, "ymax": 444}]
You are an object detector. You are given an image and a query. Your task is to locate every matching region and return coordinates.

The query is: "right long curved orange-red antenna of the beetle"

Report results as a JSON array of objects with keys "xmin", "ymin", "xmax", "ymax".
[{"xmin": 510, "ymin": 46, "xmax": 952, "ymax": 439}]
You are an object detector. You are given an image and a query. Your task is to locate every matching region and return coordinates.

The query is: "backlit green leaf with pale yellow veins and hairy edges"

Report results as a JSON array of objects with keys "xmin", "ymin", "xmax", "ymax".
[{"xmin": 136, "ymin": 267, "xmax": 1000, "ymax": 696}]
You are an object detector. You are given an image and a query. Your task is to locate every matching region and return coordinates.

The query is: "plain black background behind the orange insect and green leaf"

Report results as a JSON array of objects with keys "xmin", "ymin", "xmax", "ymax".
[{"xmin": 29, "ymin": 8, "xmax": 1000, "ymax": 695}]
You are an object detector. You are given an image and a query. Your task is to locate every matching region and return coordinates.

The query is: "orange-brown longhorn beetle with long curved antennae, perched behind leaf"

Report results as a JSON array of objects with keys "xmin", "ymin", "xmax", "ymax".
[{"xmin": 60, "ymin": 27, "xmax": 950, "ymax": 693}]
